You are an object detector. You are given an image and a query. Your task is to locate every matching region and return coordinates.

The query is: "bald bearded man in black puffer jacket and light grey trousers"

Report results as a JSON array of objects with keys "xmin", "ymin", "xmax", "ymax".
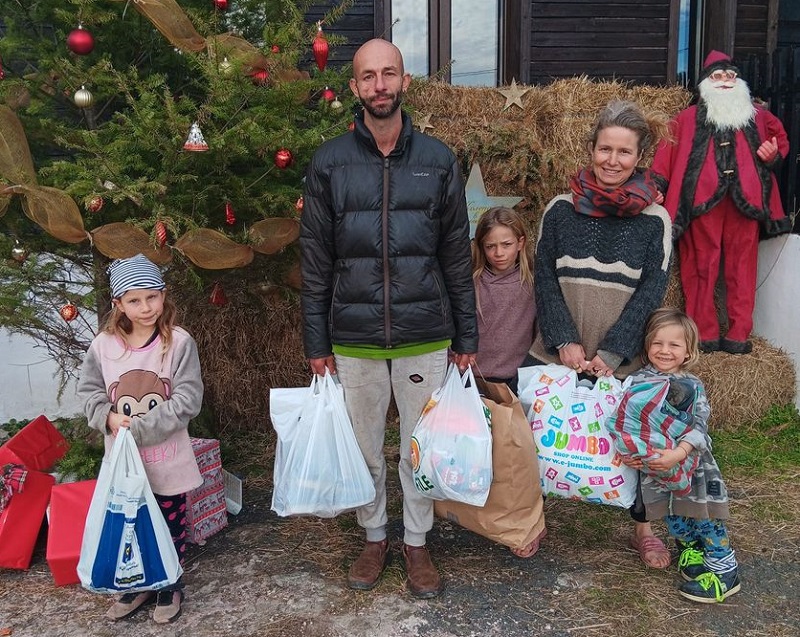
[{"xmin": 300, "ymin": 39, "xmax": 478, "ymax": 599}]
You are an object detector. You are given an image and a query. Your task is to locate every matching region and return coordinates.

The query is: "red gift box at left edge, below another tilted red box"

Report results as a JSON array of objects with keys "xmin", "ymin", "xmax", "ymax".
[{"xmin": 0, "ymin": 471, "xmax": 56, "ymax": 569}]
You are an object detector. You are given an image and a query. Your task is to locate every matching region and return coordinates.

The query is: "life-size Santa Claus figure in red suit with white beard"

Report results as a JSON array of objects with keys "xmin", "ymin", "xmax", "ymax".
[{"xmin": 652, "ymin": 51, "xmax": 791, "ymax": 354}]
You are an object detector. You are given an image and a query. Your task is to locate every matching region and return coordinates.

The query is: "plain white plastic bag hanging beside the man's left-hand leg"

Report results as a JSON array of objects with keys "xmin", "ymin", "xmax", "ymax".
[{"xmin": 269, "ymin": 372, "xmax": 375, "ymax": 518}]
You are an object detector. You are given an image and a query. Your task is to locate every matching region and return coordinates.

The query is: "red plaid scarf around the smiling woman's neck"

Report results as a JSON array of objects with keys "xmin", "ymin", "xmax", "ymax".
[{"xmin": 569, "ymin": 168, "xmax": 658, "ymax": 217}]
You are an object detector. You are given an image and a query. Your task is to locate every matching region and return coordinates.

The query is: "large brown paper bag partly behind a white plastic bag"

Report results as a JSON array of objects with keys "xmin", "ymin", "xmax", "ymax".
[{"xmin": 434, "ymin": 379, "xmax": 545, "ymax": 549}]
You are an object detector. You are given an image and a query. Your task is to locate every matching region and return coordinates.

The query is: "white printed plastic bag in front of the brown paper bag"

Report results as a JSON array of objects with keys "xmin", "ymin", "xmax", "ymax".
[{"xmin": 411, "ymin": 364, "xmax": 492, "ymax": 506}]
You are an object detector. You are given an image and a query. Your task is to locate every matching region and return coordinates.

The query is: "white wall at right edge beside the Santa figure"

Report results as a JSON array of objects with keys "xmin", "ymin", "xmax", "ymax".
[{"xmin": 753, "ymin": 234, "xmax": 800, "ymax": 409}]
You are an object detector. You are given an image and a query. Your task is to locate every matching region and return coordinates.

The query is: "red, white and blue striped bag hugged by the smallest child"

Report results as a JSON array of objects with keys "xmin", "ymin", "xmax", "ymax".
[{"xmin": 608, "ymin": 377, "xmax": 700, "ymax": 496}]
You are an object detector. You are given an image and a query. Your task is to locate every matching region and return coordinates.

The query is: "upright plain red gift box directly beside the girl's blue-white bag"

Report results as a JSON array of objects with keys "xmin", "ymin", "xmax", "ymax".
[{"xmin": 47, "ymin": 480, "xmax": 97, "ymax": 586}]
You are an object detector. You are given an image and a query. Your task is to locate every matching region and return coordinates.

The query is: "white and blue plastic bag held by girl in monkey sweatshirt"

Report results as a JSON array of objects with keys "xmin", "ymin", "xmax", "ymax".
[{"xmin": 78, "ymin": 427, "xmax": 183, "ymax": 593}]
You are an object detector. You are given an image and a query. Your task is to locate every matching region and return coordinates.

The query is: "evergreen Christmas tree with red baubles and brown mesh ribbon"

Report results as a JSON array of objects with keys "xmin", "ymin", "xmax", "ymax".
[{"xmin": 0, "ymin": 0, "xmax": 353, "ymax": 412}]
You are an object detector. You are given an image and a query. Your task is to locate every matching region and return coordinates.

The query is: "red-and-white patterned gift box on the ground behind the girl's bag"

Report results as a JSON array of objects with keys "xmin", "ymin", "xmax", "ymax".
[{"xmin": 186, "ymin": 438, "xmax": 228, "ymax": 544}]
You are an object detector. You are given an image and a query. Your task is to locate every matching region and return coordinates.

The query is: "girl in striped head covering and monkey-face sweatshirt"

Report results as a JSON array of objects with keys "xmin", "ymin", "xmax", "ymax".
[{"xmin": 78, "ymin": 254, "xmax": 203, "ymax": 624}]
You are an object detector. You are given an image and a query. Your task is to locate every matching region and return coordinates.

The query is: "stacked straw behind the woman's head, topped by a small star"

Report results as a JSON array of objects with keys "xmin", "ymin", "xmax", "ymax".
[{"xmin": 407, "ymin": 77, "xmax": 691, "ymax": 222}]
